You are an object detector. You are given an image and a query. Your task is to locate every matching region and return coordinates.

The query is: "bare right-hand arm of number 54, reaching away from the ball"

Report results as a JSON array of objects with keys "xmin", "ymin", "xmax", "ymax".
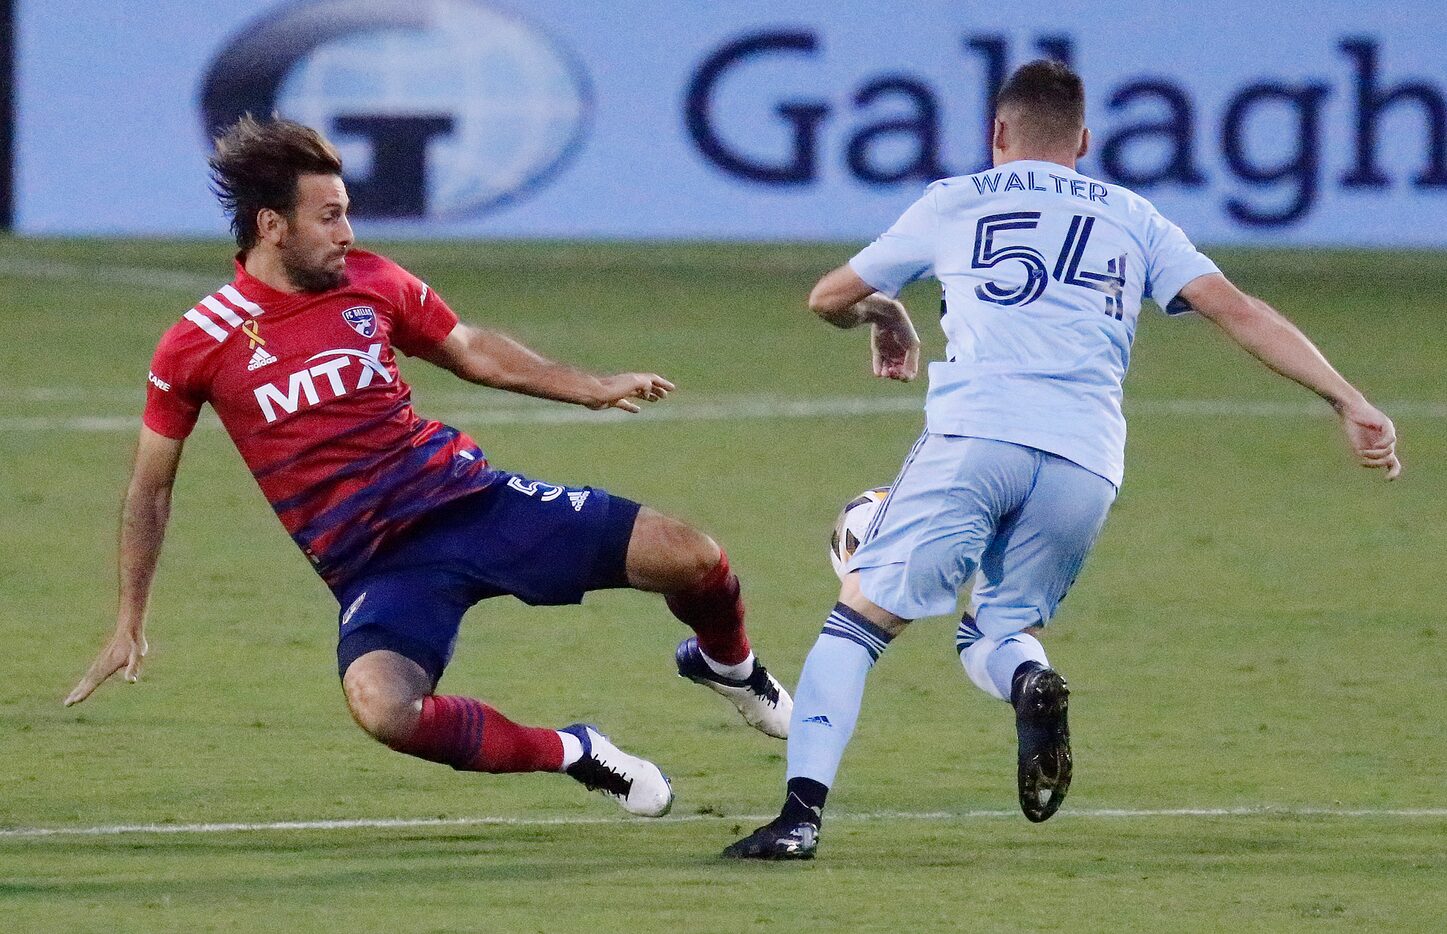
[{"xmin": 1178, "ymin": 274, "xmax": 1402, "ymax": 479}]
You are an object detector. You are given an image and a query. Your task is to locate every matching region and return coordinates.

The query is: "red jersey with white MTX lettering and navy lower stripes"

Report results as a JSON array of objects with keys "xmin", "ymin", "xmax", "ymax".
[{"xmin": 143, "ymin": 249, "xmax": 496, "ymax": 588}]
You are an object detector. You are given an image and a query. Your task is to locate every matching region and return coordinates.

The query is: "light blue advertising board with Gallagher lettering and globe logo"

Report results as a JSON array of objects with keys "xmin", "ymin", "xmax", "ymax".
[{"xmin": 14, "ymin": 0, "xmax": 1447, "ymax": 246}]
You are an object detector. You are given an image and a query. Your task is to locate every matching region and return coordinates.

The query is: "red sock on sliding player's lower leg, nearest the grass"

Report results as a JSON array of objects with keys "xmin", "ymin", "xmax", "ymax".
[{"xmin": 392, "ymin": 695, "xmax": 563, "ymax": 772}]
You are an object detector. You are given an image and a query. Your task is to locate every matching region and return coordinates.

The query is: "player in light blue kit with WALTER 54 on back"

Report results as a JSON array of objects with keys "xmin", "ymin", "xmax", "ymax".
[{"xmin": 724, "ymin": 61, "xmax": 1401, "ymax": 859}]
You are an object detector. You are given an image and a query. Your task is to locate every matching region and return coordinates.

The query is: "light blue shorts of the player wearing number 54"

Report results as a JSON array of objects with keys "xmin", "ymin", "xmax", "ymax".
[{"xmin": 849, "ymin": 432, "xmax": 1116, "ymax": 639}]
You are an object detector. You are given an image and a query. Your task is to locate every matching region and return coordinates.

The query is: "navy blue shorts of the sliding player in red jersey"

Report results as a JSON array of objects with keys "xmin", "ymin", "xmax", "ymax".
[{"xmin": 336, "ymin": 474, "xmax": 640, "ymax": 685}]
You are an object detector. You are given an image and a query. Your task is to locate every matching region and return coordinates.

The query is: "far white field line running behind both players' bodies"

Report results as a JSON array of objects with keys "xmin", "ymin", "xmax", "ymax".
[{"xmin": 0, "ymin": 388, "xmax": 1447, "ymax": 433}]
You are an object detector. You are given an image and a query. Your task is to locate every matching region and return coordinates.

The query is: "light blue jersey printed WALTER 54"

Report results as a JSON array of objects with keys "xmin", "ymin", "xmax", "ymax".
[{"xmin": 849, "ymin": 161, "xmax": 1218, "ymax": 487}]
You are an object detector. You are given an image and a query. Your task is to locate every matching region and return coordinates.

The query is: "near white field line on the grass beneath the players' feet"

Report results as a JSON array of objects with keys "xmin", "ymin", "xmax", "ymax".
[{"xmin": 0, "ymin": 807, "xmax": 1447, "ymax": 840}]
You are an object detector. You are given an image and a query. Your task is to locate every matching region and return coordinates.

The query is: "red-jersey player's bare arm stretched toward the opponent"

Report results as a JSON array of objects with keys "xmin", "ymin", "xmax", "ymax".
[{"xmin": 413, "ymin": 324, "xmax": 674, "ymax": 413}]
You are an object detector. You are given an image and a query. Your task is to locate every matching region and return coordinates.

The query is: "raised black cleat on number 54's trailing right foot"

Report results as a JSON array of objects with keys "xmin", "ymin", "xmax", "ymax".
[{"xmin": 1010, "ymin": 665, "xmax": 1074, "ymax": 824}]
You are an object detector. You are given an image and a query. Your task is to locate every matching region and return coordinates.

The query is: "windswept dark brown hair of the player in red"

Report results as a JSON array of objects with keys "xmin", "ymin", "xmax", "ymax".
[{"xmin": 207, "ymin": 113, "xmax": 341, "ymax": 251}]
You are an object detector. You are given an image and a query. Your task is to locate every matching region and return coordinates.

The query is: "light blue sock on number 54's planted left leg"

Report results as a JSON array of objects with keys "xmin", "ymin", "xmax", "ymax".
[{"xmin": 787, "ymin": 604, "xmax": 893, "ymax": 785}]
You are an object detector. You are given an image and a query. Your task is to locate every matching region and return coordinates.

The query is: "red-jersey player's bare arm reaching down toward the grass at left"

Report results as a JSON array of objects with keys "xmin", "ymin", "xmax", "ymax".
[{"xmin": 65, "ymin": 427, "xmax": 182, "ymax": 707}]
